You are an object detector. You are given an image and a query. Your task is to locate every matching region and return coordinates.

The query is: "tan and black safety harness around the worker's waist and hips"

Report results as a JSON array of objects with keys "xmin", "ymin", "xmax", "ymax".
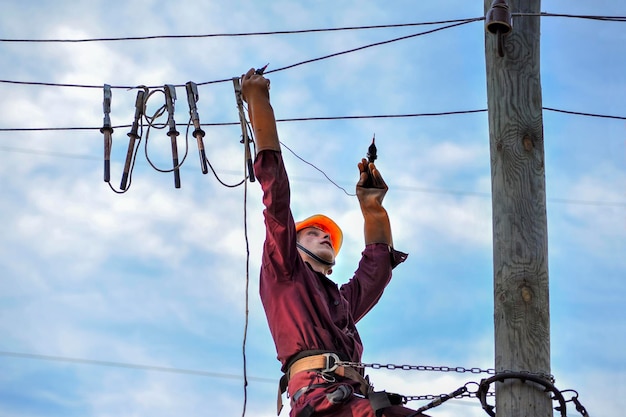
[{"xmin": 277, "ymin": 351, "xmax": 402, "ymax": 417}]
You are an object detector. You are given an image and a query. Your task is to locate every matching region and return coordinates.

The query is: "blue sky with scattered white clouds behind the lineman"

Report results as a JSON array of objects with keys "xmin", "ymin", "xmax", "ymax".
[{"xmin": 0, "ymin": 0, "xmax": 626, "ymax": 417}]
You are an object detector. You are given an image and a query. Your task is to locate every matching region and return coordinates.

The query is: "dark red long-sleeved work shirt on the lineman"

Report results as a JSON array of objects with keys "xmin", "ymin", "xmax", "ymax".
[{"xmin": 254, "ymin": 150, "xmax": 406, "ymax": 371}]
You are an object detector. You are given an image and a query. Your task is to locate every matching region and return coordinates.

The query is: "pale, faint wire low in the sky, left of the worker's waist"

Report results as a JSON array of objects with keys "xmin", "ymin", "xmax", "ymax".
[{"xmin": 0, "ymin": 351, "xmax": 276, "ymax": 383}]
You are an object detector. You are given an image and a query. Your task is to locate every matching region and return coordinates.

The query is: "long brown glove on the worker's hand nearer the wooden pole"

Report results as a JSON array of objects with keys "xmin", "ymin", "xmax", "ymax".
[{"xmin": 356, "ymin": 158, "xmax": 393, "ymax": 246}]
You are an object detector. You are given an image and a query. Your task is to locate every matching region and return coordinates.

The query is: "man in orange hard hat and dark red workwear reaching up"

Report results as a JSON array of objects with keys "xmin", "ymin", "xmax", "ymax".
[{"xmin": 242, "ymin": 69, "xmax": 422, "ymax": 417}]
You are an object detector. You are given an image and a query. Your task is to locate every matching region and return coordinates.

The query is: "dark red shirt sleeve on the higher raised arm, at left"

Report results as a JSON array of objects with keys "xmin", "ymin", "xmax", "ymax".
[{"xmin": 254, "ymin": 150, "xmax": 298, "ymax": 281}]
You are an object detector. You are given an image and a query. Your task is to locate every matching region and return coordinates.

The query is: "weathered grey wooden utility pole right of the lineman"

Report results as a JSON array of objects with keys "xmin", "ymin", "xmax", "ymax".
[{"xmin": 484, "ymin": 0, "xmax": 553, "ymax": 417}]
